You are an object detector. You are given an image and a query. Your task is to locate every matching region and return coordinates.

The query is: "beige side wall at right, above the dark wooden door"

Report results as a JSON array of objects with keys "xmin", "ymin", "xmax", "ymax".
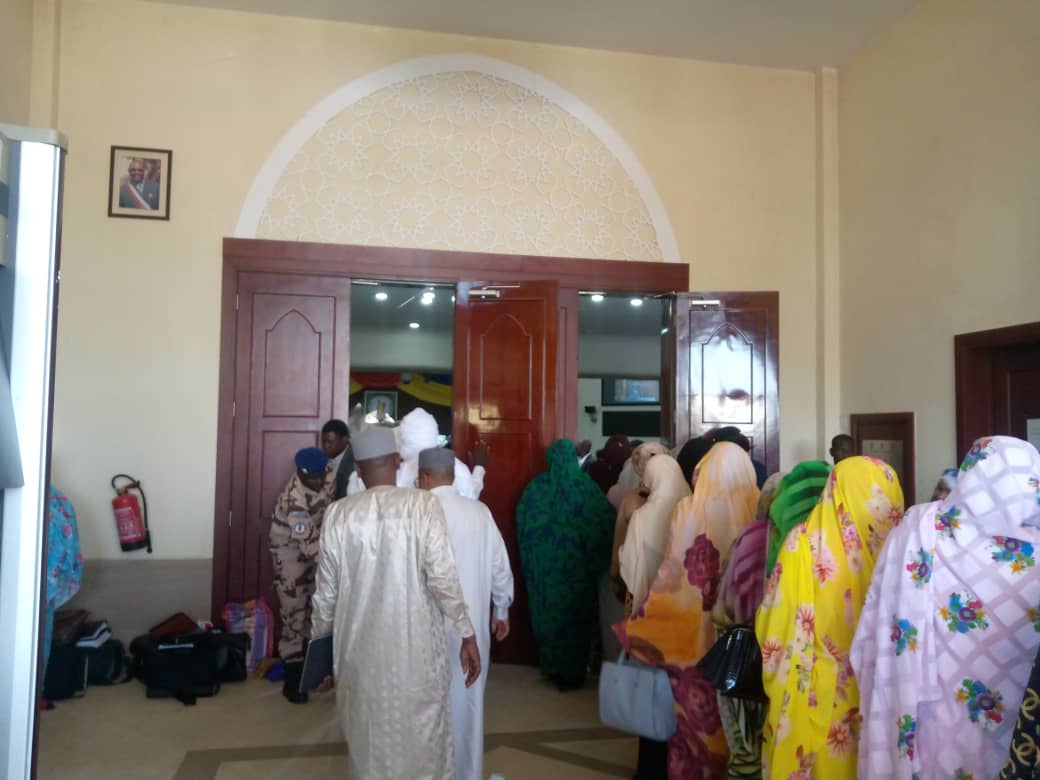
[{"xmin": 839, "ymin": 0, "xmax": 1040, "ymax": 498}]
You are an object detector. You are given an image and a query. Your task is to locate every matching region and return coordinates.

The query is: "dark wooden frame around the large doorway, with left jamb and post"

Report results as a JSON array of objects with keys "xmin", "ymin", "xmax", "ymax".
[{"xmin": 211, "ymin": 238, "xmax": 690, "ymax": 619}]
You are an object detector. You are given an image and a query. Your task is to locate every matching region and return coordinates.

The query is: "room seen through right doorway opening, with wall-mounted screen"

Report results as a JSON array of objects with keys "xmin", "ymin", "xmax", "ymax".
[{"xmin": 577, "ymin": 292, "xmax": 666, "ymax": 452}]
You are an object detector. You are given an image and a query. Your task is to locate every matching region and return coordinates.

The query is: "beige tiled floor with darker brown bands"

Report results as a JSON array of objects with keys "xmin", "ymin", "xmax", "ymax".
[{"xmin": 38, "ymin": 667, "xmax": 635, "ymax": 780}]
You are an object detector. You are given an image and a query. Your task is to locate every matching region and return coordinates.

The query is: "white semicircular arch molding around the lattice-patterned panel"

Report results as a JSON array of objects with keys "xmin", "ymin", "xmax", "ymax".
[{"xmin": 235, "ymin": 53, "xmax": 681, "ymax": 262}]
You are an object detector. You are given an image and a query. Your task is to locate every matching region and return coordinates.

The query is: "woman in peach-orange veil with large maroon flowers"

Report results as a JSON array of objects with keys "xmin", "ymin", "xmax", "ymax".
[{"xmin": 617, "ymin": 442, "xmax": 758, "ymax": 780}]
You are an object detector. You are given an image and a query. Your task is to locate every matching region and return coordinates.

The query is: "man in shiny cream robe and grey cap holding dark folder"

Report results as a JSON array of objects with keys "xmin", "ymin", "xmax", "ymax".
[{"xmin": 311, "ymin": 426, "xmax": 480, "ymax": 780}]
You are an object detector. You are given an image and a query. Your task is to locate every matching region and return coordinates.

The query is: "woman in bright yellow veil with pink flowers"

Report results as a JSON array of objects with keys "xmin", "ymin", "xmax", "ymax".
[{"xmin": 755, "ymin": 458, "xmax": 903, "ymax": 780}]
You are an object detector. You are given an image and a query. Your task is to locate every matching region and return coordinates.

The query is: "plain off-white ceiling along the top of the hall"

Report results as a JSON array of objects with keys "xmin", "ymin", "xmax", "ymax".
[{"xmin": 148, "ymin": 0, "xmax": 918, "ymax": 70}]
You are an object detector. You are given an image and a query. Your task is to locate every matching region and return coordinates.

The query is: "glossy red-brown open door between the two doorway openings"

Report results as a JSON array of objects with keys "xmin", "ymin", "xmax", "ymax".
[{"xmin": 452, "ymin": 282, "xmax": 560, "ymax": 664}]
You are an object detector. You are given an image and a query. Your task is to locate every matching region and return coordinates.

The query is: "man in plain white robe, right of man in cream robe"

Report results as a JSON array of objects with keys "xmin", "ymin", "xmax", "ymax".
[{"xmin": 418, "ymin": 449, "xmax": 513, "ymax": 780}]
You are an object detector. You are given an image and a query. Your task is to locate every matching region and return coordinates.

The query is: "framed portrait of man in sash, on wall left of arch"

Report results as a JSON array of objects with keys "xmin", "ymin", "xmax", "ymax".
[{"xmin": 108, "ymin": 147, "xmax": 174, "ymax": 219}]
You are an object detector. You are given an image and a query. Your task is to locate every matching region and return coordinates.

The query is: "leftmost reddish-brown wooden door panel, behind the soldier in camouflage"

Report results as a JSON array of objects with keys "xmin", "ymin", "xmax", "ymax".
[{"xmin": 221, "ymin": 274, "xmax": 350, "ymax": 624}]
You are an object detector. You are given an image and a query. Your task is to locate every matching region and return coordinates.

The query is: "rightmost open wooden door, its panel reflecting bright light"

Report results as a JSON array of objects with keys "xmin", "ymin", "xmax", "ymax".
[{"xmin": 665, "ymin": 292, "xmax": 780, "ymax": 473}]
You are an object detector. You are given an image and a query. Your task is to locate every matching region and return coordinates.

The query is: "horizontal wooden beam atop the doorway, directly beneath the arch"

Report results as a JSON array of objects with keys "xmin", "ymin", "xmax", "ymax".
[{"xmin": 224, "ymin": 238, "xmax": 690, "ymax": 293}]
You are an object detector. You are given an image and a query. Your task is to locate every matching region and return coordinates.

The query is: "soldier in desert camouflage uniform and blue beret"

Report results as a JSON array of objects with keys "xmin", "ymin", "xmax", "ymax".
[{"xmin": 268, "ymin": 447, "xmax": 336, "ymax": 704}]
